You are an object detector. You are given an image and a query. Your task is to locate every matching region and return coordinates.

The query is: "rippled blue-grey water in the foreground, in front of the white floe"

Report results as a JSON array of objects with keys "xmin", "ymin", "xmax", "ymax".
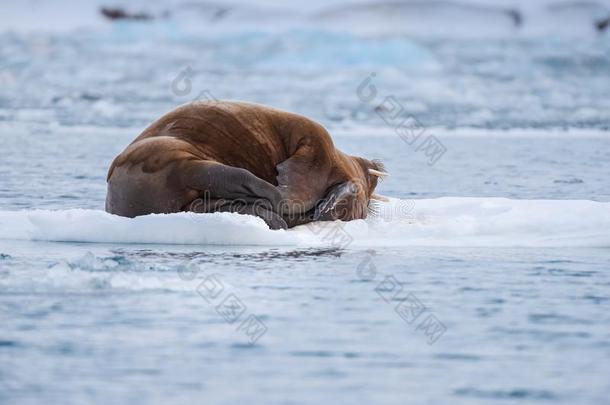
[{"xmin": 0, "ymin": 243, "xmax": 610, "ymax": 404}]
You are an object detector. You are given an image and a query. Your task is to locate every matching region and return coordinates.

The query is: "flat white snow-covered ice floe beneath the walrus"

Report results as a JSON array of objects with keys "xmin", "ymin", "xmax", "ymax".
[{"xmin": 0, "ymin": 197, "xmax": 610, "ymax": 248}]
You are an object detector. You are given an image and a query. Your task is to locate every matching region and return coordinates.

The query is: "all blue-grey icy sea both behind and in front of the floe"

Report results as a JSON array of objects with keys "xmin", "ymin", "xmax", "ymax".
[{"xmin": 0, "ymin": 1, "xmax": 610, "ymax": 404}]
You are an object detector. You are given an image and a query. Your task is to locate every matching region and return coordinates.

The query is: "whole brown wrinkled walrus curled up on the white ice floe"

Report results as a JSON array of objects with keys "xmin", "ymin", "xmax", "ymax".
[{"xmin": 106, "ymin": 101, "xmax": 386, "ymax": 229}]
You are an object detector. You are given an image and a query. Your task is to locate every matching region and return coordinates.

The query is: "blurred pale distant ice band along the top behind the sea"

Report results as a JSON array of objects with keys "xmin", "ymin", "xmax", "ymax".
[{"xmin": 0, "ymin": 0, "xmax": 610, "ymax": 37}]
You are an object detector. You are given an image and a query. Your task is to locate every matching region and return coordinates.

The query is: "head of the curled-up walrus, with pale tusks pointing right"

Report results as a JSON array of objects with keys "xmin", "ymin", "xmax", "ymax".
[{"xmin": 314, "ymin": 156, "xmax": 388, "ymax": 221}]
